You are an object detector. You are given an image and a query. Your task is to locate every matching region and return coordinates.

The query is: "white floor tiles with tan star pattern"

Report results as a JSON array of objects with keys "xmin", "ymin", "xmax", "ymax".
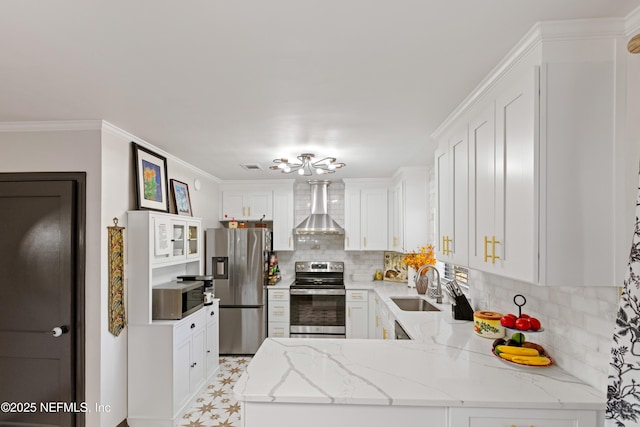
[{"xmin": 176, "ymin": 356, "xmax": 251, "ymax": 427}]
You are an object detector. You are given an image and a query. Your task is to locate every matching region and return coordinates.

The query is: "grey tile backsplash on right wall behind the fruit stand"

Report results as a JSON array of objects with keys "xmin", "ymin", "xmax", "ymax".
[{"xmin": 469, "ymin": 270, "xmax": 618, "ymax": 393}]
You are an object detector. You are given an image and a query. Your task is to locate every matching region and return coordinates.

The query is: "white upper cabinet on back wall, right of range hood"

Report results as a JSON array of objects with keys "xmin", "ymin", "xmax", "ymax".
[{"xmin": 344, "ymin": 179, "xmax": 388, "ymax": 251}]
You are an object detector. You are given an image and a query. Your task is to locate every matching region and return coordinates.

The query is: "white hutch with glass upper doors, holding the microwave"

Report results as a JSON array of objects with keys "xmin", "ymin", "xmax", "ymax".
[{"xmin": 125, "ymin": 211, "xmax": 217, "ymax": 427}]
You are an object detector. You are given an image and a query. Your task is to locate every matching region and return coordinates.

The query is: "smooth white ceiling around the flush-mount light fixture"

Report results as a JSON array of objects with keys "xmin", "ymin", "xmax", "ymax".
[{"xmin": 0, "ymin": 0, "xmax": 640, "ymax": 179}]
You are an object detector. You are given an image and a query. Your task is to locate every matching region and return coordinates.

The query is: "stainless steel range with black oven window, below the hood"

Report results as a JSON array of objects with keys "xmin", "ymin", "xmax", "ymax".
[{"xmin": 289, "ymin": 261, "xmax": 346, "ymax": 338}]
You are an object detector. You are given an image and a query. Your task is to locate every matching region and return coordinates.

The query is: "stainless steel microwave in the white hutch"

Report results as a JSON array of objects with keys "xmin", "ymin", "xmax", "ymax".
[{"xmin": 151, "ymin": 280, "xmax": 204, "ymax": 320}]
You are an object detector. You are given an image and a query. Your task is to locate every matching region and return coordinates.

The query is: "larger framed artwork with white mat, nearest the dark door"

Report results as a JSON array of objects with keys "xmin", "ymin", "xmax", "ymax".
[{"xmin": 131, "ymin": 142, "xmax": 169, "ymax": 212}]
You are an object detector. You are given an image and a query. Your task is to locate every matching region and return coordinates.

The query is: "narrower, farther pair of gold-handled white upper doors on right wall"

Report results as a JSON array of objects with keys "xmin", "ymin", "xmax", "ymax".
[{"xmin": 435, "ymin": 124, "xmax": 469, "ymax": 265}]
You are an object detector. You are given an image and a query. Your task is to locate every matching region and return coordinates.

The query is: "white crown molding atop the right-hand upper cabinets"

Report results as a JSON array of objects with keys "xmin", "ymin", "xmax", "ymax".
[{"xmin": 431, "ymin": 18, "xmax": 624, "ymax": 141}]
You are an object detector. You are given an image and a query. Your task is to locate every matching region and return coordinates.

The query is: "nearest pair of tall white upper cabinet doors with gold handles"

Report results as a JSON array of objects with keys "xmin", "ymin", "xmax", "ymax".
[{"xmin": 469, "ymin": 67, "xmax": 538, "ymax": 282}]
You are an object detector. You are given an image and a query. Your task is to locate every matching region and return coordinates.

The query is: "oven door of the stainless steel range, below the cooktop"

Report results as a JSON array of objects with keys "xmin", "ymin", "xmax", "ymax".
[{"xmin": 289, "ymin": 287, "xmax": 346, "ymax": 338}]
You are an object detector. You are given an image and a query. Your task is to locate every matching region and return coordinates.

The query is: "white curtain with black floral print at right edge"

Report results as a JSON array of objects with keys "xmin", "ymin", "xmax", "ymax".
[{"xmin": 605, "ymin": 168, "xmax": 640, "ymax": 427}]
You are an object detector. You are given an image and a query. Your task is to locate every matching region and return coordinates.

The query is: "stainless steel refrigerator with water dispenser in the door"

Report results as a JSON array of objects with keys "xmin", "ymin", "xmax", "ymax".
[{"xmin": 206, "ymin": 228, "xmax": 271, "ymax": 354}]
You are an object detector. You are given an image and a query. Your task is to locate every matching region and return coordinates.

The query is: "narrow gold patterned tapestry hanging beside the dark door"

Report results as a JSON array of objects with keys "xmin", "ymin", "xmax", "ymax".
[{"xmin": 107, "ymin": 218, "xmax": 127, "ymax": 336}]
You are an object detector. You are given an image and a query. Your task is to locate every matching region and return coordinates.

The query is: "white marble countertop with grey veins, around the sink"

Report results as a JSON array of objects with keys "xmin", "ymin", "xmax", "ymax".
[{"xmin": 234, "ymin": 282, "xmax": 606, "ymax": 410}]
